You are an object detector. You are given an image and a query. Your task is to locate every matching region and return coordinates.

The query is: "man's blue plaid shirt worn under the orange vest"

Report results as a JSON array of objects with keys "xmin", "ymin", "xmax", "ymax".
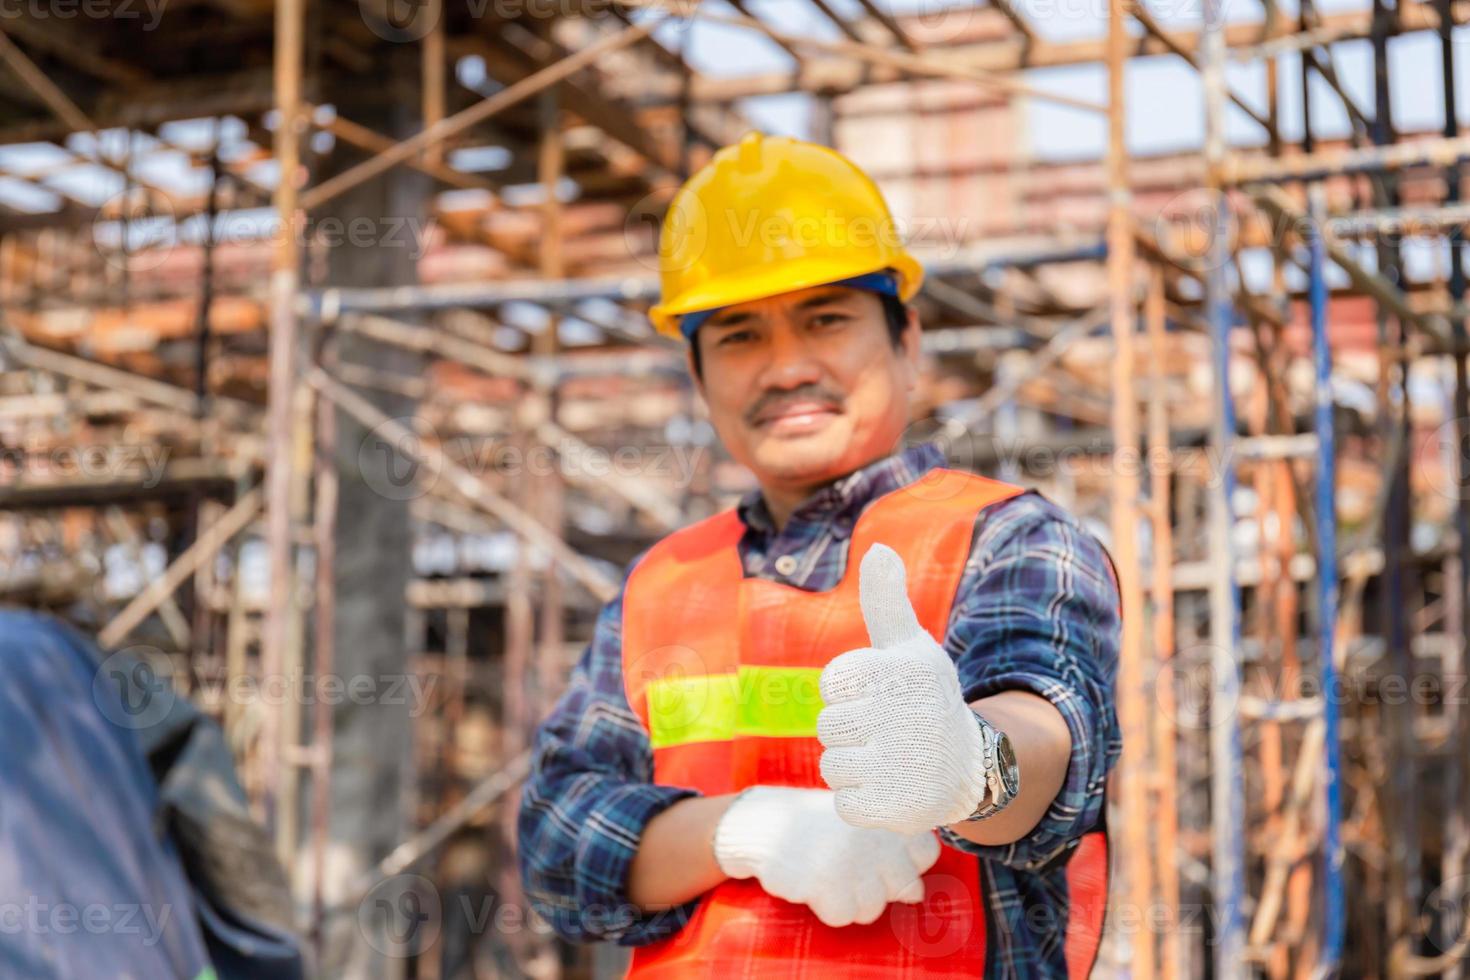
[{"xmin": 519, "ymin": 444, "xmax": 1122, "ymax": 977}]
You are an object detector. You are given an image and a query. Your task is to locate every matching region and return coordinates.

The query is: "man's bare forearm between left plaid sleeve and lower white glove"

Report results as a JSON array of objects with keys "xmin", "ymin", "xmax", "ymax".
[{"xmin": 628, "ymin": 793, "xmax": 735, "ymax": 912}]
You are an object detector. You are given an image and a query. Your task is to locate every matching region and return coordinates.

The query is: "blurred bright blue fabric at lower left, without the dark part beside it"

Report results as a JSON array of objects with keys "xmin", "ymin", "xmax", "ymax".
[{"xmin": 0, "ymin": 610, "xmax": 212, "ymax": 980}]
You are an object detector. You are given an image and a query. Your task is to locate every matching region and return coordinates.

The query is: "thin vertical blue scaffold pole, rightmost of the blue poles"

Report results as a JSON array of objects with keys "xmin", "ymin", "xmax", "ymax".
[{"xmin": 1307, "ymin": 184, "xmax": 1344, "ymax": 976}]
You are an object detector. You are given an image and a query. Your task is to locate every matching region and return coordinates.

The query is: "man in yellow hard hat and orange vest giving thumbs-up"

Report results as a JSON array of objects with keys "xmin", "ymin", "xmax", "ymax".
[{"xmin": 519, "ymin": 134, "xmax": 1120, "ymax": 979}]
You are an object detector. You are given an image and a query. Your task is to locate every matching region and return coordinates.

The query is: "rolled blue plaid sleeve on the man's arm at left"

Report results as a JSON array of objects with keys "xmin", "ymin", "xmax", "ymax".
[{"xmin": 517, "ymin": 558, "xmax": 698, "ymax": 946}]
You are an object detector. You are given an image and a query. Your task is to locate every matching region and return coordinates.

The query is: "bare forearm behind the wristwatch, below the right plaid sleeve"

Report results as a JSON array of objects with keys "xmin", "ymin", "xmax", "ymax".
[{"xmin": 950, "ymin": 691, "xmax": 1072, "ymax": 845}]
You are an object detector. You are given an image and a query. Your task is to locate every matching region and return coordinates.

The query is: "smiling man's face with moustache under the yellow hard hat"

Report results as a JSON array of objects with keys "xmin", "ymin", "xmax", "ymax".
[{"xmin": 691, "ymin": 287, "xmax": 919, "ymax": 491}]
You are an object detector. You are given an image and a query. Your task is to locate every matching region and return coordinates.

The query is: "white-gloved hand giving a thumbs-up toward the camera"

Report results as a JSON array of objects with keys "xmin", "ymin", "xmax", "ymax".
[{"xmin": 817, "ymin": 544, "xmax": 985, "ymax": 833}]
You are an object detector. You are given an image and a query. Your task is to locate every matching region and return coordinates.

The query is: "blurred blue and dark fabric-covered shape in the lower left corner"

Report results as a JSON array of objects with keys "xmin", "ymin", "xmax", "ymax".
[{"xmin": 0, "ymin": 610, "xmax": 304, "ymax": 980}]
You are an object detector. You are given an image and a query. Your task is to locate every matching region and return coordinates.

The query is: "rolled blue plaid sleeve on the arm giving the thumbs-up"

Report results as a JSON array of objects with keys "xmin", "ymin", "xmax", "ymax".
[{"xmin": 941, "ymin": 494, "xmax": 1123, "ymax": 871}]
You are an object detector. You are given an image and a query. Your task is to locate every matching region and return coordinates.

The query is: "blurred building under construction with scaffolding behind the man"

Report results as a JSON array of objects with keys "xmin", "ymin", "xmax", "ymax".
[{"xmin": 0, "ymin": 0, "xmax": 1470, "ymax": 979}]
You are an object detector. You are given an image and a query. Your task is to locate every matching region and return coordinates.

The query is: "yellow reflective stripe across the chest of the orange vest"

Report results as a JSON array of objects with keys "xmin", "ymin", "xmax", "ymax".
[{"xmin": 644, "ymin": 664, "xmax": 822, "ymax": 749}]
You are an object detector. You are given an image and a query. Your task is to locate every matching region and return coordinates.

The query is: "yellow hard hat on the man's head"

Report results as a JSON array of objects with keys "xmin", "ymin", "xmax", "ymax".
[{"xmin": 648, "ymin": 132, "xmax": 923, "ymax": 338}]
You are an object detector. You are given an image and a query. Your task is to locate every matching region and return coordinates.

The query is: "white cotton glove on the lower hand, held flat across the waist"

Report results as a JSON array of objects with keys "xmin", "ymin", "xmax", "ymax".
[{"xmin": 714, "ymin": 786, "xmax": 939, "ymax": 926}]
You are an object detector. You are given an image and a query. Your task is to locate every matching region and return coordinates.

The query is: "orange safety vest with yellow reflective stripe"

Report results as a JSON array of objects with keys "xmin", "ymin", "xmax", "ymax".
[{"xmin": 623, "ymin": 467, "xmax": 1107, "ymax": 980}]
